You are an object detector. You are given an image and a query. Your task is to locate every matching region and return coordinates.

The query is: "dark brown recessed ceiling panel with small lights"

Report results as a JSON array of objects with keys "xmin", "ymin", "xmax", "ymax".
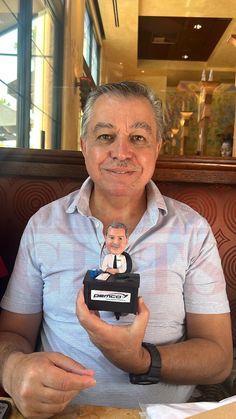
[{"xmin": 138, "ymin": 16, "xmax": 231, "ymax": 61}]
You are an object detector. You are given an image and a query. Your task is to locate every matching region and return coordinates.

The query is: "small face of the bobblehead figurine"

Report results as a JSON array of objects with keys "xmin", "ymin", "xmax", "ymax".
[{"xmin": 105, "ymin": 227, "xmax": 128, "ymax": 255}]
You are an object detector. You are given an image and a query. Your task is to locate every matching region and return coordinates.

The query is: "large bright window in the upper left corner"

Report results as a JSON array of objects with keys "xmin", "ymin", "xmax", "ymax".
[{"xmin": 0, "ymin": 0, "xmax": 63, "ymax": 148}]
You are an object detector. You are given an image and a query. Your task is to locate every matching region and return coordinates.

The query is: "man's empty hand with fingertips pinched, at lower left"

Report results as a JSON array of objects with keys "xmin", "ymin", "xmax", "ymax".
[{"xmin": 3, "ymin": 352, "xmax": 96, "ymax": 418}]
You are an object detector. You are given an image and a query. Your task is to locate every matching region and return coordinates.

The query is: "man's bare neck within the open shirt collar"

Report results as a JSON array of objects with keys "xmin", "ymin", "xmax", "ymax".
[{"xmin": 90, "ymin": 188, "xmax": 147, "ymax": 234}]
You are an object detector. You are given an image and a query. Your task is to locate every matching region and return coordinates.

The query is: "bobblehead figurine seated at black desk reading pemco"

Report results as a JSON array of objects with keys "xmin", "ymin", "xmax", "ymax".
[{"xmin": 84, "ymin": 222, "xmax": 140, "ymax": 320}]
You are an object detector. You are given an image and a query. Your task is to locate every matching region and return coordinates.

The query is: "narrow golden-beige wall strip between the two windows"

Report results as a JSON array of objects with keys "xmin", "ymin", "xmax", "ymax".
[{"xmin": 61, "ymin": 0, "xmax": 85, "ymax": 150}]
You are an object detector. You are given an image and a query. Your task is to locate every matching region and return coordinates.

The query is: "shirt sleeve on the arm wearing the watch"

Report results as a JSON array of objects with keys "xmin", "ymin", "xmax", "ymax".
[{"xmin": 184, "ymin": 218, "xmax": 230, "ymax": 314}]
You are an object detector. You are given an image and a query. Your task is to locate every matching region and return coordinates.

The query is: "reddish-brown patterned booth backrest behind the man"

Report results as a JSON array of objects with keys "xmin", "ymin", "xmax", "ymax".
[{"xmin": 0, "ymin": 150, "xmax": 236, "ymax": 344}]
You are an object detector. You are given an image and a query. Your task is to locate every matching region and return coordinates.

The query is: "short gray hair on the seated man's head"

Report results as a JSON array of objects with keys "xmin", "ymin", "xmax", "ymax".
[{"xmin": 81, "ymin": 81, "xmax": 164, "ymax": 142}]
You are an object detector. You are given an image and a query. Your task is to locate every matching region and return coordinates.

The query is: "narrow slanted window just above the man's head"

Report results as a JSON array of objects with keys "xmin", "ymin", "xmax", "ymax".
[{"xmin": 83, "ymin": 7, "xmax": 100, "ymax": 84}]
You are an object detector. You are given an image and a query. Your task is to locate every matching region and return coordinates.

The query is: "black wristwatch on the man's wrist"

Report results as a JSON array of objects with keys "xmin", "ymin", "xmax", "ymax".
[{"xmin": 129, "ymin": 342, "xmax": 161, "ymax": 385}]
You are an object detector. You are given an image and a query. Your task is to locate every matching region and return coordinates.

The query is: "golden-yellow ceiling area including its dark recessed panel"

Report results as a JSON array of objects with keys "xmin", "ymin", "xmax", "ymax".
[{"xmin": 98, "ymin": 0, "xmax": 236, "ymax": 91}]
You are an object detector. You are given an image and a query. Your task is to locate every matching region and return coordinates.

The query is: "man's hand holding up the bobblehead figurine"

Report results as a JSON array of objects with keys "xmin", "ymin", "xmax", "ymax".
[{"xmin": 76, "ymin": 289, "xmax": 150, "ymax": 373}]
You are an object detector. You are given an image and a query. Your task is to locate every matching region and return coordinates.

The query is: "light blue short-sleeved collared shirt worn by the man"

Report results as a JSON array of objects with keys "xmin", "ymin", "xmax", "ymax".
[{"xmin": 1, "ymin": 178, "xmax": 229, "ymax": 407}]
